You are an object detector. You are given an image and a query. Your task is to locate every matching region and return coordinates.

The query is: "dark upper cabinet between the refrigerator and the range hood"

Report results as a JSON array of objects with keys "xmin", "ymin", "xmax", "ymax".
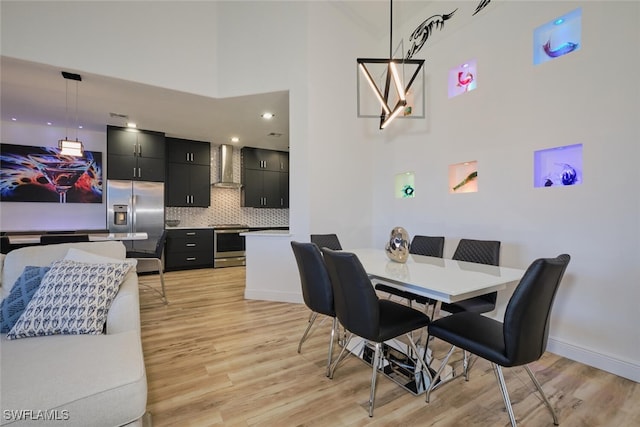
[{"xmin": 165, "ymin": 138, "xmax": 211, "ymax": 208}]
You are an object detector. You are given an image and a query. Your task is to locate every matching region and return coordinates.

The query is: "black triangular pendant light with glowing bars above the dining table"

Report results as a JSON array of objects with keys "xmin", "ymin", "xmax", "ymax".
[{"xmin": 356, "ymin": 0, "xmax": 424, "ymax": 129}]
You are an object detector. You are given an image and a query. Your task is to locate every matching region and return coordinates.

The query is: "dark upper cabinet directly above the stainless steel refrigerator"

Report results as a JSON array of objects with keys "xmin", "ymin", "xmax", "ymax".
[{"xmin": 107, "ymin": 126, "xmax": 165, "ymax": 182}]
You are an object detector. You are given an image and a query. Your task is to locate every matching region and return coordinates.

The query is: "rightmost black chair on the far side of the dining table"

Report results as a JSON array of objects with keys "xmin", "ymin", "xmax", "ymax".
[{"xmin": 442, "ymin": 239, "xmax": 500, "ymax": 313}]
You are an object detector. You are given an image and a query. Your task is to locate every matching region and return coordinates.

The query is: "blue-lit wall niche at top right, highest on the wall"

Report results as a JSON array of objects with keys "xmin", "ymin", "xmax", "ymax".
[{"xmin": 533, "ymin": 8, "xmax": 582, "ymax": 65}]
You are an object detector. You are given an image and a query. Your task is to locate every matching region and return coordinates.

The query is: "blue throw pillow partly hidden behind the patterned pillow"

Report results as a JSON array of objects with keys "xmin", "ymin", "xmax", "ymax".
[{"xmin": 0, "ymin": 265, "xmax": 49, "ymax": 333}]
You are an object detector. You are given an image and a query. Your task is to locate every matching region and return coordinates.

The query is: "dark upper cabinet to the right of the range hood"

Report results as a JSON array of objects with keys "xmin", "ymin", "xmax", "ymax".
[{"xmin": 242, "ymin": 147, "xmax": 289, "ymax": 208}]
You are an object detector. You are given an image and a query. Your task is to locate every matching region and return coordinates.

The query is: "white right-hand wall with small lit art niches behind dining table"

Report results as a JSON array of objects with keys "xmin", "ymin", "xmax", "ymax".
[{"xmin": 372, "ymin": 2, "xmax": 640, "ymax": 381}]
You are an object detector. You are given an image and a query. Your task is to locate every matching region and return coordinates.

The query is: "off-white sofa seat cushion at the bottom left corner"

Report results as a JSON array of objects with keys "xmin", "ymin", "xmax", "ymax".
[{"xmin": 0, "ymin": 331, "xmax": 147, "ymax": 427}]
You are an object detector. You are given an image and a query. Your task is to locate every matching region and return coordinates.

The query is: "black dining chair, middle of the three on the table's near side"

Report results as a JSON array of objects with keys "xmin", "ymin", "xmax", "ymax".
[{"xmin": 322, "ymin": 248, "xmax": 430, "ymax": 417}]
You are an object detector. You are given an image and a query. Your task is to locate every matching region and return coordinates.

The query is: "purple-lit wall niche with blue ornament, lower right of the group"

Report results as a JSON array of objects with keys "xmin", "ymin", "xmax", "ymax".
[{"xmin": 533, "ymin": 144, "xmax": 582, "ymax": 187}]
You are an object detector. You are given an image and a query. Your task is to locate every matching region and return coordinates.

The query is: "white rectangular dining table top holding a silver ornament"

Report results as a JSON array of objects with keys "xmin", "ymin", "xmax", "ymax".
[{"xmin": 346, "ymin": 248, "xmax": 524, "ymax": 303}]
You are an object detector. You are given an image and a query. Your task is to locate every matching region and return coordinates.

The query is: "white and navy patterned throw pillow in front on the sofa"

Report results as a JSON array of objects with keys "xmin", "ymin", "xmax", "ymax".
[{"xmin": 7, "ymin": 260, "xmax": 131, "ymax": 339}]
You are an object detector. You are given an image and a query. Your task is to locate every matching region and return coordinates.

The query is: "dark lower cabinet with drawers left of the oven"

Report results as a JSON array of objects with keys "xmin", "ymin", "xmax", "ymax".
[{"xmin": 164, "ymin": 228, "xmax": 213, "ymax": 270}]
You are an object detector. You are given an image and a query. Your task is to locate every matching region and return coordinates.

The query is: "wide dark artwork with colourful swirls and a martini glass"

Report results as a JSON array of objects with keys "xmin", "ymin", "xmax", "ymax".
[{"xmin": 0, "ymin": 144, "xmax": 103, "ymax": 203}]
